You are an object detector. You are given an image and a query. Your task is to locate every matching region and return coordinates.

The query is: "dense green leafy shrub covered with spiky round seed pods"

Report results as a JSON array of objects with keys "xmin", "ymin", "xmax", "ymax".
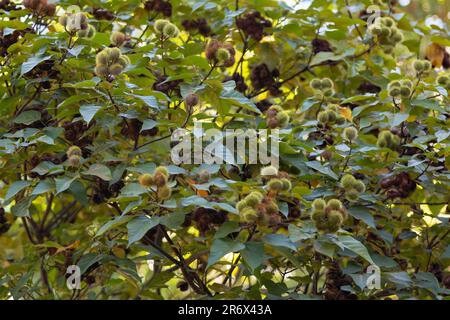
[{"xmin": 0, "ymin": 0, "xmax": 450, "ymax": 299}]
